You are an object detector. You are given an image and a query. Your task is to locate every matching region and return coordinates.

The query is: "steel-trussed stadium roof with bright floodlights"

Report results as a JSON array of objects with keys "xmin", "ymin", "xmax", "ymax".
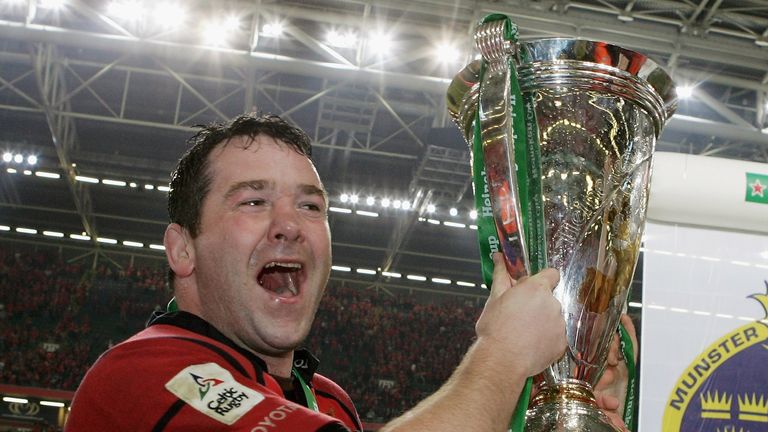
[{"xmin": 0, "ymin": 0, "xmax": 768, "ymax": 290}]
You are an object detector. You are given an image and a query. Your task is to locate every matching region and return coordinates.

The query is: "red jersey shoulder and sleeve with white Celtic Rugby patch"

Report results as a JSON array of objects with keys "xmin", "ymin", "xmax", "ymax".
[{"xmin": 67, "ymin": 326, "xmax": 344, "ymax": 432}]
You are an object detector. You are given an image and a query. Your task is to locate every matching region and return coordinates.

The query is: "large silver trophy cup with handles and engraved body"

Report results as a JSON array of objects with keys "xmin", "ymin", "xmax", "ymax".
[{"xmin": 448, "ymin": 18, "xmax": 676, "ymax": 432}]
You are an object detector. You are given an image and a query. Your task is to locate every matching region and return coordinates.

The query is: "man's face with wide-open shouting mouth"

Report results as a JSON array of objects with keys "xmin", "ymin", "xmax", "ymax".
[{"xmin": 191, "ymin": 135, "xmax": 331, "ymax": 355}]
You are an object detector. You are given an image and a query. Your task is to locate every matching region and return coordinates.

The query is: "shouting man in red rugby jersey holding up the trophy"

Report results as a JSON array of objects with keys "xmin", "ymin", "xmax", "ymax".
[{"xmin": 66, "ymin": 116, "xmax": 566, "ymax": 432}]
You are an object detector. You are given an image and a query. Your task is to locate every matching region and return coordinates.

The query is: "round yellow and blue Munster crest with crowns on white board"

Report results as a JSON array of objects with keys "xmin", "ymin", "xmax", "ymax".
[{"xmin": 663, "ymin": 281, "xmax": 768, "ymax": 432}]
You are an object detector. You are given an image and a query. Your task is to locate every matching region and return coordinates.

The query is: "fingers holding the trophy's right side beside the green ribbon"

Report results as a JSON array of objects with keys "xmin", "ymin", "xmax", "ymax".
[{"xmin": 595, "ymin": 314, "xmax": 637, "ymax": 431}]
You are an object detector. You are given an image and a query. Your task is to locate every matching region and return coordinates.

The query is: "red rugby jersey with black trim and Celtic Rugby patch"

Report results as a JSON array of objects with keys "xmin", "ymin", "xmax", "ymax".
[{"xmin": 65, "ymin": 312, "xmax": 362, "ymax": 432}]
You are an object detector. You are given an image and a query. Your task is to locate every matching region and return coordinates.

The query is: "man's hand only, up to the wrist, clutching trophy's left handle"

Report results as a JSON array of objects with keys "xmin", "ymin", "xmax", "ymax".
[{"xmin": 476, "ymin": 253, "xmax": 566, "ymax": 376}]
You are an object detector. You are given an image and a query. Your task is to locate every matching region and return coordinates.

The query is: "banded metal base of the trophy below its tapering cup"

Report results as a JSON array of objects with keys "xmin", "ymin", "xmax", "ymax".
[{"xmin": 525, "ymin": 381, "xmax": 621, "ymax": 432}]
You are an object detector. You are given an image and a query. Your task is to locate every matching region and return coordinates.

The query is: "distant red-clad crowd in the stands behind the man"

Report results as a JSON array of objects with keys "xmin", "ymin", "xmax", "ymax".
[{"xmin": 0, "ymin": 248, "xmax": 481, "ymax": 422}]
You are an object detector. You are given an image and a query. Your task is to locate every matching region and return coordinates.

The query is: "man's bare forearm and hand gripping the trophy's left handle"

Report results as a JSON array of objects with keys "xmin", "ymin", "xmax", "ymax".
[{"xmin": 382, "ymin": 254, "xmax": 566, "ymax": 432}]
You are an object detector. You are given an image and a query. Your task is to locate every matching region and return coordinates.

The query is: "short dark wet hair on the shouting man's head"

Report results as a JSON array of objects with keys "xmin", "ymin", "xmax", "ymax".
[{"xmin": 168, "ymin": 114, "xmax": 312, "ymax": 237}]
